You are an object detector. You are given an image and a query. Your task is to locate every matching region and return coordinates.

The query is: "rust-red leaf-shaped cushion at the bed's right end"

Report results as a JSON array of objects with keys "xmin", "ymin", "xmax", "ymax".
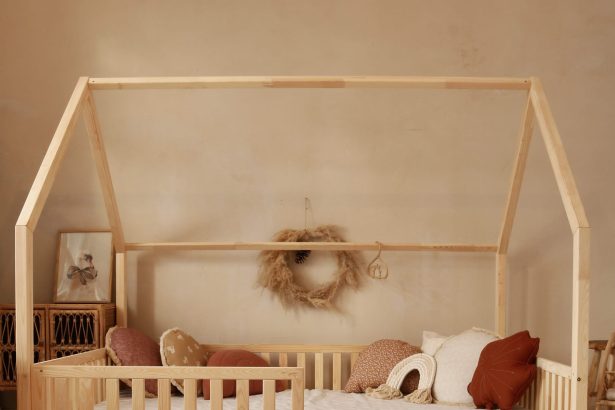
[{"xmin": 468, "ymin": 330, "xmax": 540, "ymax": 410}]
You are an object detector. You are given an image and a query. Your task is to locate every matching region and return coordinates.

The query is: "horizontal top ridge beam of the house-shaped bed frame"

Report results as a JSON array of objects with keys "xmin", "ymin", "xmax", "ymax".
[{"xmin": 89, "ymin": 76, "xmax": 531, "ymax": 90}]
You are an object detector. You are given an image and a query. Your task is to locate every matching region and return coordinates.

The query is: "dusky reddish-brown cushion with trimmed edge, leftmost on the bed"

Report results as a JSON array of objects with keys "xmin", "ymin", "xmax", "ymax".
[{"xmin": 105, "ymin": 326, "xmax": 162, "ymax": 397}]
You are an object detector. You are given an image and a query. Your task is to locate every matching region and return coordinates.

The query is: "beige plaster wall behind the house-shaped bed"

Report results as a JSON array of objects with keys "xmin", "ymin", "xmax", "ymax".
[{"xmin": 0, "ymin": 0, "xmax": 615, "ymax": 404}]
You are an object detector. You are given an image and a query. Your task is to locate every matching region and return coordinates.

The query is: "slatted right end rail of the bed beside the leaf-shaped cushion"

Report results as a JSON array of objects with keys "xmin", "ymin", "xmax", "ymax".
[{"xmin": 519, "ymin": 358, "xmax": 572, "ymax": 410}]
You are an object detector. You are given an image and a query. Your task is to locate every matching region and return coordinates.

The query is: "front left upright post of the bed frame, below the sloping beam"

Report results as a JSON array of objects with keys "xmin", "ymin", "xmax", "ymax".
[{"xmin": 15, "ymin": 225, "xmax": 34, "ymax": 410}]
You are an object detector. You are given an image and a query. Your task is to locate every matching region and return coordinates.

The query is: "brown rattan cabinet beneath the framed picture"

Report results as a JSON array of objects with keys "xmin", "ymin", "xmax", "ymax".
[{"xmin": 0, "ymin": 303, "xmax": 115, "ymax": 391}]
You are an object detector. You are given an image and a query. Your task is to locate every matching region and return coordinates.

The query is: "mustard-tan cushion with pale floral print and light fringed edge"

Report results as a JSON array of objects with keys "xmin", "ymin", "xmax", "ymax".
[{"xmin": 160, "ymin": 328, "xmax": 207, "ymax": 394}]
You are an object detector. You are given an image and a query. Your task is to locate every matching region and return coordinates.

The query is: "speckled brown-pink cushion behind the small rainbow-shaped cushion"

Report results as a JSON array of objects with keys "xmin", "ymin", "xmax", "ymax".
[{"xmin": 344, "ymin": 339, "xmax": 421, "ymax": 394}]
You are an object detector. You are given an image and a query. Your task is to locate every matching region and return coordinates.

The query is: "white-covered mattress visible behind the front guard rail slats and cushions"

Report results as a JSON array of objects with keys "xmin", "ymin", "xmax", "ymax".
[{"xmin": 94, "ymin": 390, "xmax": 470, "ymax": 410}]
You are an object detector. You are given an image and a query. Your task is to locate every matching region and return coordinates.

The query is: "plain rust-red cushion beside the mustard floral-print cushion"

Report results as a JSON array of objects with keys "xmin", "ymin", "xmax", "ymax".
[{"xmin": 203, "ymin": 350, "xmax": 285, "ymax": 400}]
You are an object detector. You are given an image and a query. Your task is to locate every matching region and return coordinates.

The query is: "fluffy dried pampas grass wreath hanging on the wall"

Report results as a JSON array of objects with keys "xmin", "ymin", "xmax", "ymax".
[{"xmin": 258, "ymin": 225, "xmax": 360, "ymax": 309}]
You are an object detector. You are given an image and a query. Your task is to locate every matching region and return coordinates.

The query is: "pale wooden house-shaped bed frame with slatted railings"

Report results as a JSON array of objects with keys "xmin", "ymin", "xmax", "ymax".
[{"xmin": 15, "ymin": 76, "xmax": 590, "ymax": 410}]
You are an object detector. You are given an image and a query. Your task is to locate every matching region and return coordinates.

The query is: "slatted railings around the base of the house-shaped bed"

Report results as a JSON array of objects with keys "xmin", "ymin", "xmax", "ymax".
[{"xmin": 32, "ymin": 345, "xmax": 573, "ymax": 410}]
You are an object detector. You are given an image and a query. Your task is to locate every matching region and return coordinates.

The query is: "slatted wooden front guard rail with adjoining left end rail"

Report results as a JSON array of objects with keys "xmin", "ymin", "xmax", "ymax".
[{"xmin": 32, "ymin": 349, "xmax": 305, "ymax": 410}]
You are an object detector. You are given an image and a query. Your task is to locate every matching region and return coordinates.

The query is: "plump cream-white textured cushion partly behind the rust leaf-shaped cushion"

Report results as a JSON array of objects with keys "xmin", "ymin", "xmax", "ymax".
[{"xmin": 432, "ymin": 328, "xmax": 498, "ymax": 405}]
